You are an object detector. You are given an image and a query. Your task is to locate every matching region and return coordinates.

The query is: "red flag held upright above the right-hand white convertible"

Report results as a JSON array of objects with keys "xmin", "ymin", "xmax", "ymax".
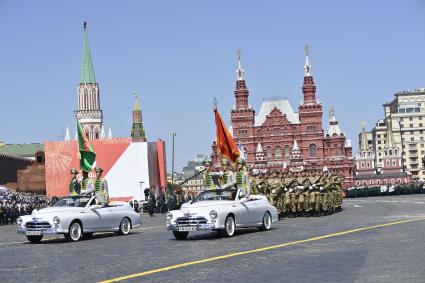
[{"xmin": 214, "ymin": 109, "xmax": 239, "ymax": 162}]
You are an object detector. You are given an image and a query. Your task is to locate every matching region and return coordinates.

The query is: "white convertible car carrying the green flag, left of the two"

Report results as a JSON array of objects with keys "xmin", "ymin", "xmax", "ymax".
[{"xmin": 16, "ymin": 196, "xmax": 142, "ymax": 243}]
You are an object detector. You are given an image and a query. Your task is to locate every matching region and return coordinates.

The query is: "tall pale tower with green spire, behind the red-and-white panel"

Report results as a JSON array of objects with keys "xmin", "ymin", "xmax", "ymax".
[{"xmin": 75, "ymin": 22, "xmax": 105, "ymax": 139}]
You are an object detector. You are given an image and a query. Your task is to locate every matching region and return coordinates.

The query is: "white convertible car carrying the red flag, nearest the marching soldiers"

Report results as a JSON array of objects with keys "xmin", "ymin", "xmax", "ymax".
[{"xmin": 166, "ymin": 189, "xmax": 278, "ymax": 240}]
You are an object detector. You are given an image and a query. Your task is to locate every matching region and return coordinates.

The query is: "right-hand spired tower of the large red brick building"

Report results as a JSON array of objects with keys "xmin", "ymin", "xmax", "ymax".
[{"xmin": 298, "ymin": 47, "xmax": 324, "ymax": 169}]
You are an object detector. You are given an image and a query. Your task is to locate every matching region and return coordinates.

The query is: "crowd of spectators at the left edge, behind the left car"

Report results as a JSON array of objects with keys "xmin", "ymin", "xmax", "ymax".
[{"xmin": 0, "ymin": 189, "xmax": 58, "ymax": 225}]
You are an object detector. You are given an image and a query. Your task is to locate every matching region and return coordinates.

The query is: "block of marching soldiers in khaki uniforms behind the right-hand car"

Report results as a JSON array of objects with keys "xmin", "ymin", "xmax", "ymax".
[{"xmin": 252, "ymin": 171, "xmax": 344, "ymax": 217}]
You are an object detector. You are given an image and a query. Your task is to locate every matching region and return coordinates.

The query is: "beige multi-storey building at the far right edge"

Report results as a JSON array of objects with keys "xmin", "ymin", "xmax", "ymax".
[{"xmin": 362, "ymin": 88, "xmax": 425, "ymax": 180}]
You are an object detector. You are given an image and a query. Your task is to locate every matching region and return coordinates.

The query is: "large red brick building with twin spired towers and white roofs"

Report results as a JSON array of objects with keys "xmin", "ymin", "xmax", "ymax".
[{"xmin": 231, "ymin": 48, "xmax": 354, "ymax": 188}]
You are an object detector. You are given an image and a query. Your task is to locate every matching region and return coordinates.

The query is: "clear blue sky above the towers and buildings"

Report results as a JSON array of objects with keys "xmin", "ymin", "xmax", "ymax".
[{"xmin": 0, "ymin": 0, "xmax": 425, "ymax": 171}]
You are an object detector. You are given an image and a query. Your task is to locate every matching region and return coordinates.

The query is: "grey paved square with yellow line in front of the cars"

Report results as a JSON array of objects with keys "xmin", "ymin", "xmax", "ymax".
[{"xmin": 0, "ymin": 195, "xmax": 425, "ymax": 282}]
